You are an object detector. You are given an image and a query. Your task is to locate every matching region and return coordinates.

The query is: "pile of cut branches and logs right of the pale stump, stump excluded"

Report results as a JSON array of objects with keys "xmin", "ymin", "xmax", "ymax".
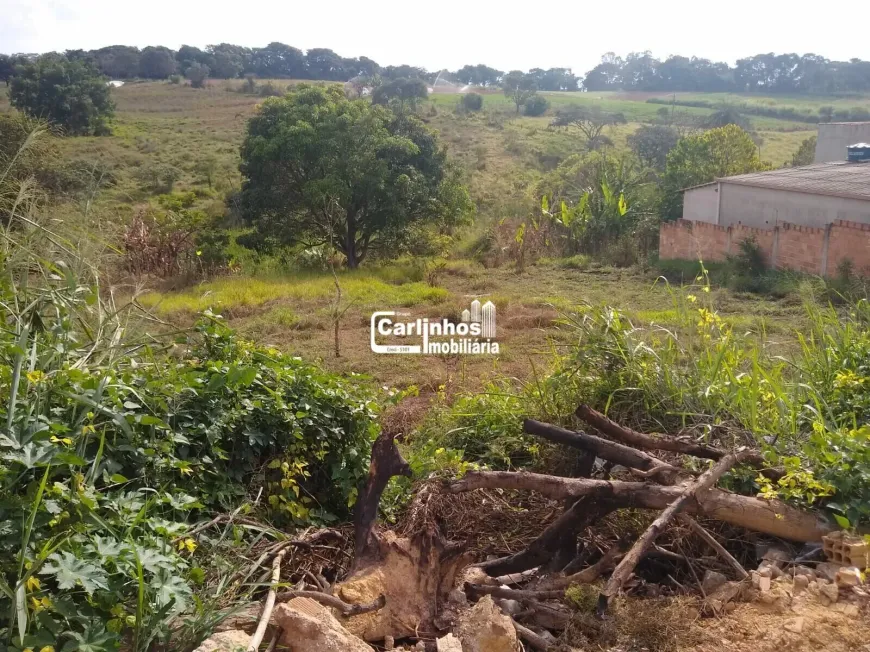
[{"xmin": 445, "ymin": 405, "xmax": 831, "ymax": 649}]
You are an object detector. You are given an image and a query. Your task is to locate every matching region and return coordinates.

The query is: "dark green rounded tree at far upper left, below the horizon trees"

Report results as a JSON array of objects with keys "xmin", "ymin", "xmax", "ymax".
[{"xmin": 9, "ymin": 54, "xmax": 115, "ymax": 135}]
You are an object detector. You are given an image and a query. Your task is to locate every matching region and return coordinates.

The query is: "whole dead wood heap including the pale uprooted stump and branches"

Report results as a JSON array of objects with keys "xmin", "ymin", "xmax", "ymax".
[{"xmin": 208, "ymin": 406, "xmax": 832, "ymax": 650}]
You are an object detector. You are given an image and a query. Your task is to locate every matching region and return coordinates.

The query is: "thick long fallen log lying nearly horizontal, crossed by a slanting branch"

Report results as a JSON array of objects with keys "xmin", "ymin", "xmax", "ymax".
[{"xmin": 448, "ymin": 471, "xmax": 834, "ymax": 542}]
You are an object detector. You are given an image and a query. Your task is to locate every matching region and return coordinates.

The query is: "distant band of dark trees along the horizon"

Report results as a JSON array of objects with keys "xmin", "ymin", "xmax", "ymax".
[{"xmin": 0, "ymin": 42, "xmax": 870, "ymax": 94}]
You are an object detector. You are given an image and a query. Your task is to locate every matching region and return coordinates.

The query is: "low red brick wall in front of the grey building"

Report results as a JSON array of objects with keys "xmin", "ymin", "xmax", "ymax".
[{"xmin": 659, "ymin": 220, "xmax": 870, "ymax": 276}]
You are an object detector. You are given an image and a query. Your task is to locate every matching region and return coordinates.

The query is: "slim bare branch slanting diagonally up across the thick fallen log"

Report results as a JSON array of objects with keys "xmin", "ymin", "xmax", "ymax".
[{"xmin": 597, "ymin": 453, "xmax": 745, "ymax": 616}]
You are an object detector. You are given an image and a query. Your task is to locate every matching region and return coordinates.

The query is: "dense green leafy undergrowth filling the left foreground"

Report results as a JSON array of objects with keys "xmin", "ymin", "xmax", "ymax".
[{"xmin": 0, "ymin": 204, "xmax": 377, "ymax": 652}]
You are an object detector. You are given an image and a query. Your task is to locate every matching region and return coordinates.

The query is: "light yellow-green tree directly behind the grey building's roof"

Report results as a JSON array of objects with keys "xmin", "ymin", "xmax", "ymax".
[{"xmin": 661, "ymin": 125, "xmax": 771, "ymax": 219}]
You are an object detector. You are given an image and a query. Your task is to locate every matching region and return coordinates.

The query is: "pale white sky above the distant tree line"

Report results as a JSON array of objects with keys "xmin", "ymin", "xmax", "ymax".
[{"xmin": 0, "ymin": 0, "xmax": 870, "ymax": 74}]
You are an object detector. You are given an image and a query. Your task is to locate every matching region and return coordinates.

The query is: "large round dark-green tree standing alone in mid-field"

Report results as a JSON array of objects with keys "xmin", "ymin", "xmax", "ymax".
[{"xmin": 241, "ymin": 84, "xmax": 472, "ymax": 268}]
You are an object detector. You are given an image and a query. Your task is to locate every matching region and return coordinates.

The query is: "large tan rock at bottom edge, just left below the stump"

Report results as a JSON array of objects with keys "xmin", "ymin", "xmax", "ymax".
[{"xmin": 272, "ymin": 598, "xmax": 372, "ymax": 652}]
